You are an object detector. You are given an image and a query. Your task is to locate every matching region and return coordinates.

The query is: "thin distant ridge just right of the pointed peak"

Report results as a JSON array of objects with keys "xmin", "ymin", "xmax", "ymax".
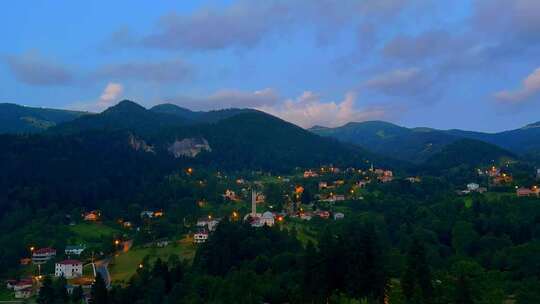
[{"xmin": 150, "ymin": 103, "xmax": 255, "ymax": 123}]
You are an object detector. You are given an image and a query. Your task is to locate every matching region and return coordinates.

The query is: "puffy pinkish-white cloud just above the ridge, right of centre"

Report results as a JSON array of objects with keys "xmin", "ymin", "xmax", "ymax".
[{"xmin": 258, "ymin": 91, "xmax": 387, "ymax": 128}]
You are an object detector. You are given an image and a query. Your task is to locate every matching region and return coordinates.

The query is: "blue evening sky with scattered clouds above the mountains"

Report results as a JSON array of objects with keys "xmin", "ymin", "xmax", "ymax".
[{"xmin": 0, "ymin": 0, "xmax": 540, "ymax": 132}]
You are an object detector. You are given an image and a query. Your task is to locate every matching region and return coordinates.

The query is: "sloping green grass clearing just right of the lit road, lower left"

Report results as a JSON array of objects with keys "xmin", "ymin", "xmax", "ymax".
[{"xmin": 109, "ymin": 238, "xmax": 195, "ymax": 282}]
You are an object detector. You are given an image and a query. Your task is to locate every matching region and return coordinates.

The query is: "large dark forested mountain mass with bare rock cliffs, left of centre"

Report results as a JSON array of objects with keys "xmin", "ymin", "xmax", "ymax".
[{"xmin": 0, "ymin": 100, "xmax": 384, "ymax": 175}]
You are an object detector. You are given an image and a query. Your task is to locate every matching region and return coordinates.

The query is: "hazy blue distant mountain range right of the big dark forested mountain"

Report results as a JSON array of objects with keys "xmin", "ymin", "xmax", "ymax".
[{"xmin": 310, "ymin": 121, "xmax": 540, "ymax": 163}]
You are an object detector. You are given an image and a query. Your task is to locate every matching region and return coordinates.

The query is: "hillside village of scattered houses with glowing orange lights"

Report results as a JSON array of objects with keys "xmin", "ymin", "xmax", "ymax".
[{"xmin": 5, "ymin": 165, "xmax": 540, "ymax": 300}]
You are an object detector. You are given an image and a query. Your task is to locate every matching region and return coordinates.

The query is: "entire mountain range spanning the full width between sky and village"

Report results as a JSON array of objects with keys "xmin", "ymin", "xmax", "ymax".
[{"xmin": 0, "ymin": 100, "xmax": 540, "ymax": 169}]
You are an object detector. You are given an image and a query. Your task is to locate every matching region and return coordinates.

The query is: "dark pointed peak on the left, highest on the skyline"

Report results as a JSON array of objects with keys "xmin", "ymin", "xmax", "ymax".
[{"xmin": 49, "ymin": 100, "xmax": 188, "ymax": 134}]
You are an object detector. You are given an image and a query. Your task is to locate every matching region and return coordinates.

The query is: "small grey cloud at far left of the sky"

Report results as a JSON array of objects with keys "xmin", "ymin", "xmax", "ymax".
[{"xmin": 5, "ymin": 54, "xmax": 75, "ymax": 86}]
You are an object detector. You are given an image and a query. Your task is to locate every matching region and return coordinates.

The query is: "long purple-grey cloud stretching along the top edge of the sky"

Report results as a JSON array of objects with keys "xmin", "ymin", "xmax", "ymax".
[{"xmin": 107, "ymin": 0, "xmax": 419, "ymax": 50}]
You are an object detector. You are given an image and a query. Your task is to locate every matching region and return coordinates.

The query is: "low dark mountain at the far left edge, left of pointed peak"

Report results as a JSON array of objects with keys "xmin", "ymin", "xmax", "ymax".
[{"xmin": 0, "ymin": 103, "xmax": 87, "ymax": 133}]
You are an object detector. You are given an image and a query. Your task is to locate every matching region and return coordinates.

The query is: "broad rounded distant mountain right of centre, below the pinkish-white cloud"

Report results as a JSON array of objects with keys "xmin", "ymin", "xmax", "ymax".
[{"xmin": 310, "ymin": 121, "xmax": 458, "ymax": 163}]
